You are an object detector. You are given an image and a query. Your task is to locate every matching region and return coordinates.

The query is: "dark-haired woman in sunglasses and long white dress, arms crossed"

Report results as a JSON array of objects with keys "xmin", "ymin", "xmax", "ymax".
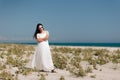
[{"xmin": 32, "ymin": 23, "xmax": 55, "ymax": 72}]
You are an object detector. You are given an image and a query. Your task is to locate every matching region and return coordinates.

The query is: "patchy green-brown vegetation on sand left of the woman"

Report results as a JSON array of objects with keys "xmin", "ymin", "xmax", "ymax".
[{"xmin": 0, "ymin": 44, "xmax": 34, "ymax": 80}]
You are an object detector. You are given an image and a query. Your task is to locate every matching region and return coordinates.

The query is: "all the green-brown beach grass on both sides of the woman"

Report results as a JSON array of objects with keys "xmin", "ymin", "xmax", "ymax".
[{"xmin": 0, "ymin": 44, "xmax": 120, "ymax": 80}]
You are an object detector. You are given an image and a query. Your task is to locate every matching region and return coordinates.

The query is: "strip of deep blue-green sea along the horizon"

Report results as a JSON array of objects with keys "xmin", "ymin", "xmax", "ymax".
[{"xmin": 20, "ymin": 42, "xmax": 120, "ymax": 47}]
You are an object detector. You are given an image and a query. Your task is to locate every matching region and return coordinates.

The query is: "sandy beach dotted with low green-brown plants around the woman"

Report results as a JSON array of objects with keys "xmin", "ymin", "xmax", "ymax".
[{"xmin": 0, "ymin": 44, "xmax": 120, "ymax": 80}]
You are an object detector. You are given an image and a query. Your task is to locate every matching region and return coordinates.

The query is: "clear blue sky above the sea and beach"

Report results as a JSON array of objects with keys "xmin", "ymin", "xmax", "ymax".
[{"xmin": 0, "ymin": 0, "xmax": 120, "ymax": 43}]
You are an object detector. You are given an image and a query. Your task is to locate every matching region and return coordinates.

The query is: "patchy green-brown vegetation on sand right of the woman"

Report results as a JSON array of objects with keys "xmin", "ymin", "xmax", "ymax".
[{"xmin": 52, "ymin": 47, "xmax": 120, "ymax": 78}]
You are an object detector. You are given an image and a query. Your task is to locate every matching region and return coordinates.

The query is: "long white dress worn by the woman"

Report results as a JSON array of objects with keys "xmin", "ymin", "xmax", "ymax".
[{"xmin": 32, "ymin": 31, "xmax": 54, "ymax": 71}]
